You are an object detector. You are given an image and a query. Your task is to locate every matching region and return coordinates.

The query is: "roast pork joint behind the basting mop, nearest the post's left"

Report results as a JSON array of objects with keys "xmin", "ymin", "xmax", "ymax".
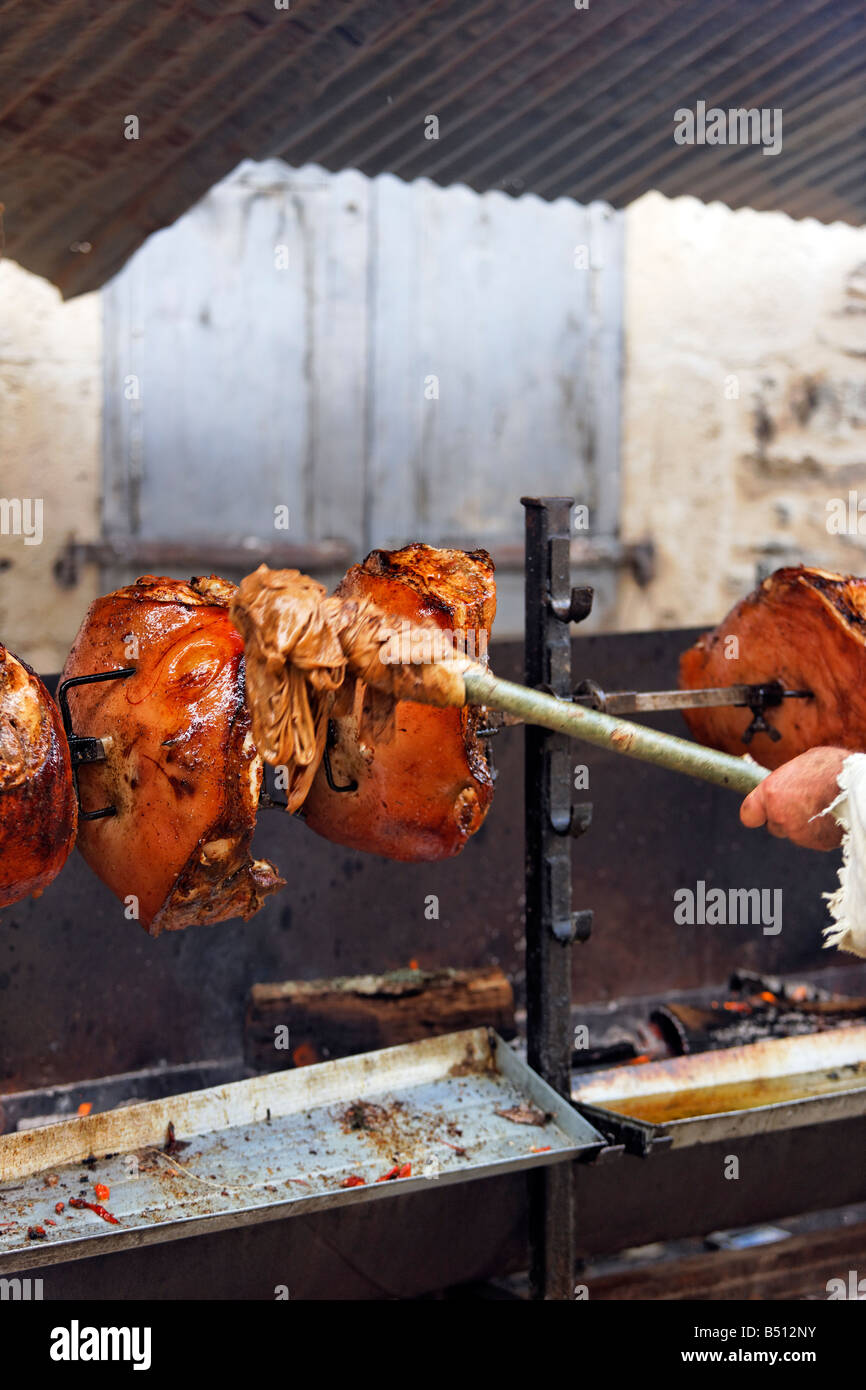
[{"xmin": 302, "ymin": 543, "xmax": 496, "ymax": 860}]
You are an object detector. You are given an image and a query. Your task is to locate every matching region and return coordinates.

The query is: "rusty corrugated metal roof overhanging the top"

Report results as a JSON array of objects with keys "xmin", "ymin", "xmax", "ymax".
[{"xmin": 0, "ymin": 0, "xmax": 866, "ymax": 295}]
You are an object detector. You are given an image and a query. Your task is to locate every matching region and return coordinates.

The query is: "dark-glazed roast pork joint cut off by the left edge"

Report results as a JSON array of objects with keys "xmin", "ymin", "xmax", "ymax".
[{"xmin": 0, "ymin": 646, "xmax": 78, "ymax": 908}]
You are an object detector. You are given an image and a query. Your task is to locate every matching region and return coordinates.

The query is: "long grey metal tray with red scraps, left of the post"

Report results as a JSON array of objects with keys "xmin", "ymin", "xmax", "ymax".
[{"xmin": 0, "ymin": 1029, "xmax": 605, "ymax": 1272}]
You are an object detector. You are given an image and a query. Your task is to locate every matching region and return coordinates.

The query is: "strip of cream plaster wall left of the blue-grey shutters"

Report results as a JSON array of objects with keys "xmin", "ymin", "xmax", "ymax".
[{"xmin": 0, "ymin": 260, "xmax": 101, "ymax": 671}]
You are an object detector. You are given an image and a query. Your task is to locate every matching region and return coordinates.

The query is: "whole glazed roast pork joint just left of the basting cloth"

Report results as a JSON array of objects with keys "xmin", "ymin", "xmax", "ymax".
[{"xmin": 64, "ymin": 575, "xmax": 282, "ymax": 935}]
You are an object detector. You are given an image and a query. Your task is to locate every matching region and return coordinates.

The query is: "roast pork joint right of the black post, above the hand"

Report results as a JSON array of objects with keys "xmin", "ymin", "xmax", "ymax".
[{"xmin": 680, "ymin": 566, "xmax": 866, "ymax": 767}]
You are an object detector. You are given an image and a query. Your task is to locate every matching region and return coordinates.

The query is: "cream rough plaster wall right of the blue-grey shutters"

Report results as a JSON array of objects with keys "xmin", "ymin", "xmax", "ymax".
[{"xmin": 617, "ymin": 193, "xmax": 866, "ymax": 630}]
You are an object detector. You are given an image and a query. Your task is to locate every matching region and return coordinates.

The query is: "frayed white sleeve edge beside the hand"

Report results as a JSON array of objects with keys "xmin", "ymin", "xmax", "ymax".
[{"xmin": 819, "ymin": 753, "xmax": 866, "ymax": 956}]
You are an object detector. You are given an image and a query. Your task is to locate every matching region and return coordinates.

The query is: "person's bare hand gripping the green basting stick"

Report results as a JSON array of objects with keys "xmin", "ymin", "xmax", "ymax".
[{"xmin": 740, "ymin": 748, "xmax": 851, "ymax": 849}]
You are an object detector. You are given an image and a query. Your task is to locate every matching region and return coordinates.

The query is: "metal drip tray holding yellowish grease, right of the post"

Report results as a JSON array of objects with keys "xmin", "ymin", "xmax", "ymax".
[{"xmin": 571, "ymin": 1026, "xmax": 866, "ymax": 1154}]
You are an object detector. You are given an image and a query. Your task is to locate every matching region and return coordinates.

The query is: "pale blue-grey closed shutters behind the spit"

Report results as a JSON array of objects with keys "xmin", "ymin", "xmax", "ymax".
[{"xmin": 104, "ymin": 160, "xmax": 624, "ymax": 631}]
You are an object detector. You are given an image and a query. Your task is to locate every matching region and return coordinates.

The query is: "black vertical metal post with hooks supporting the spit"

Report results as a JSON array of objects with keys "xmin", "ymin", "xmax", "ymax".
[{"xmin": 521, "ymin": 498, "xmax": 592, "ymax": 1300}]
